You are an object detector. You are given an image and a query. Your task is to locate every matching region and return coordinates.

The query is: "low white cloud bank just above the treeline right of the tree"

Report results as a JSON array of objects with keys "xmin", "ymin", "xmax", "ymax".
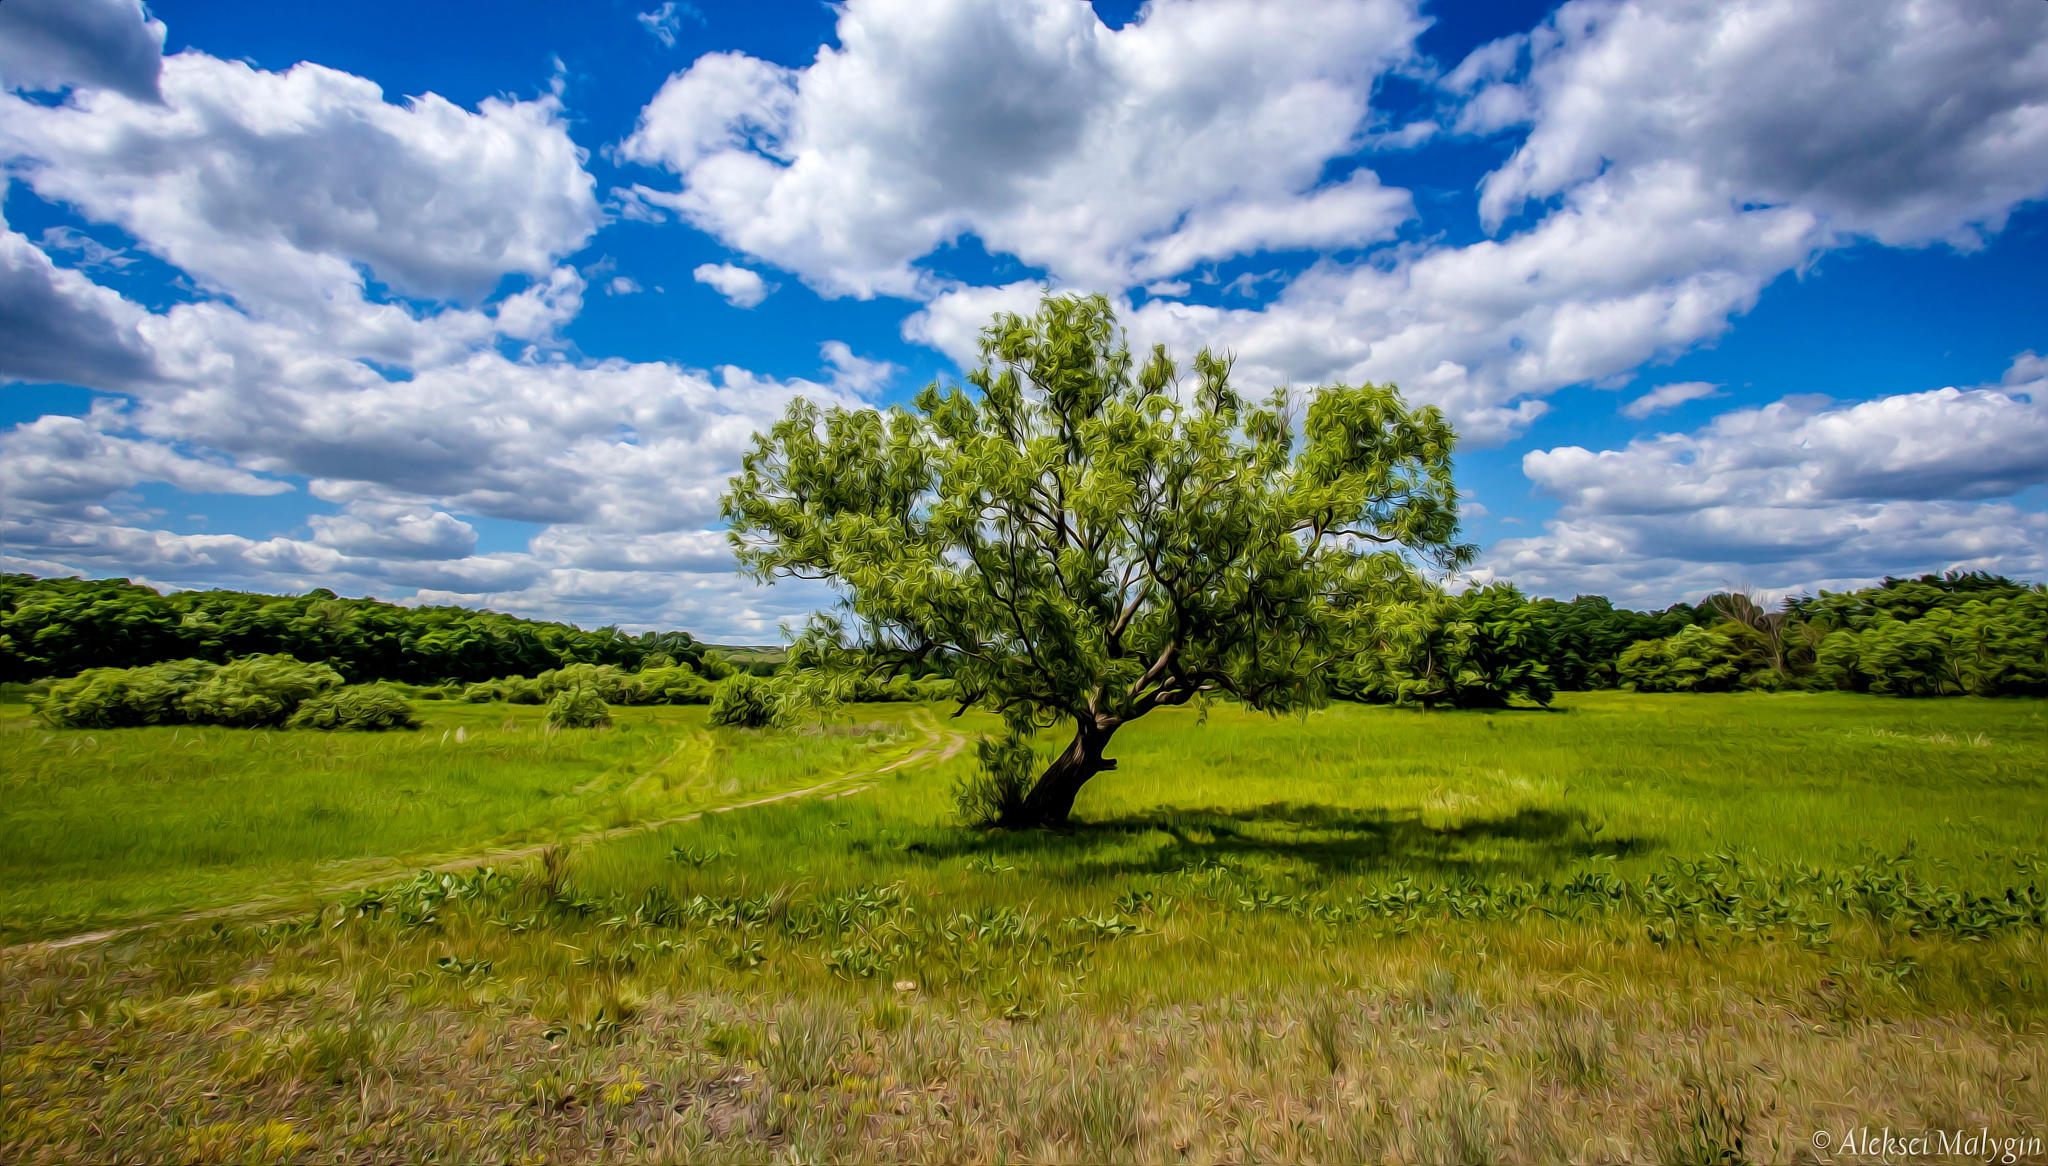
[{"xmin": 1481, "ymin": 359, "xmax": 2048, "ymax": 602}]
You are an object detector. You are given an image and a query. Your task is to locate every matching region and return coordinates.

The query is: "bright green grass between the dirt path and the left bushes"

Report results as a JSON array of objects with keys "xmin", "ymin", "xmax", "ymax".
[{"xmin": 0, "ymin": 701, "xmax": 929, "ymax": 943}]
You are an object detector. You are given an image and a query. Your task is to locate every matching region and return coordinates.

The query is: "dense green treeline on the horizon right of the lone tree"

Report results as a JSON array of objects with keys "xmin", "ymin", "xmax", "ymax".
[{"xmin": 1339, "ymin": 572, "xmax": 2048, "ymax": 707}]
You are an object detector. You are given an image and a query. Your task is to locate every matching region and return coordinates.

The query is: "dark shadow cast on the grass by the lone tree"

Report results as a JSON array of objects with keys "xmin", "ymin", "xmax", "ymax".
[{"xmin": 903, "ymin": 801, "xmax": 1657, "ymax": 881}]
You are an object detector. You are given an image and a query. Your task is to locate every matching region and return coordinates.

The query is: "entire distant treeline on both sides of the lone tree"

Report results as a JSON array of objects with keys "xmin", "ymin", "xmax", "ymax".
[{"xmin": 0, "ymin": 572, "xmax": 2048, "ymax": 707}]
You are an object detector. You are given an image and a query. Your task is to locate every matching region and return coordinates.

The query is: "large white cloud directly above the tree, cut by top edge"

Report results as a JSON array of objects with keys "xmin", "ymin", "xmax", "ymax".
[{"xmin": 621, "ymin": 0, "xmax": 1423, "ymax": 297}]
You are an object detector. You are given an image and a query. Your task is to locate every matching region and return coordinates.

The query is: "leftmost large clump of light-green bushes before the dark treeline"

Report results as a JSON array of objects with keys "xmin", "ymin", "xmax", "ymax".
[{"xmin": 33, "ymin": 656, "xmax": 354, "ymax": 730}]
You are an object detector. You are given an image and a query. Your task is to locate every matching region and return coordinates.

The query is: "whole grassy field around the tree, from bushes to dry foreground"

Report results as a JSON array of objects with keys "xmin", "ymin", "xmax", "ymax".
[{"xmin": 0, "ymin": 695, "xmax": 2048, "ymax": 1162}]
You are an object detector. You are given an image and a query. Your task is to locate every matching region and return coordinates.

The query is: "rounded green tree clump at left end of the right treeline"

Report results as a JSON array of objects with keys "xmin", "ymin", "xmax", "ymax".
[{"xmin": 1348, "ymin": 584, "xmax": 1556, "ymax": 709}]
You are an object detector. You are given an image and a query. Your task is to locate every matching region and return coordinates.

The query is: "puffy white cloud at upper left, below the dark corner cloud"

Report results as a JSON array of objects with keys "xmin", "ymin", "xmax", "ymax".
[{"xmin": 0, "ymin": 51, "xmax": 598, "ymax": 303}]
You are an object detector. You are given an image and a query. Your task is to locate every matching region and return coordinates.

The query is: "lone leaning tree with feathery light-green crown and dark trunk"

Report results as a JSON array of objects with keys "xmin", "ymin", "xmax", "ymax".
[{"xmin": 725, "ymin": 295, "xmax": 1470, "ymax": 826}]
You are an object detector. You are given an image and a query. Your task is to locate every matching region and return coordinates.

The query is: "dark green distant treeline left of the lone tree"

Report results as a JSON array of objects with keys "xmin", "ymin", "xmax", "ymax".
[{"xmin": 0, "ymin": 574, "xmax": 705, "ymax": 684}]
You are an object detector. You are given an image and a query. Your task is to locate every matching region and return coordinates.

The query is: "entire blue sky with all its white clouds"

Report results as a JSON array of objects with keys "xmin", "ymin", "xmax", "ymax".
[{"xmin": 0, "ymin": 0, "xmax": 2048, "ymax": 639}]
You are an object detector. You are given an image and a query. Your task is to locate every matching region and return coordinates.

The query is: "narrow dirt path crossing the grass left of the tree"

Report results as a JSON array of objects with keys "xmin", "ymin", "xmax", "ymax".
[{"xmin": 0, "ymin": 727, "xmax": 967, "ymax": 959}]
